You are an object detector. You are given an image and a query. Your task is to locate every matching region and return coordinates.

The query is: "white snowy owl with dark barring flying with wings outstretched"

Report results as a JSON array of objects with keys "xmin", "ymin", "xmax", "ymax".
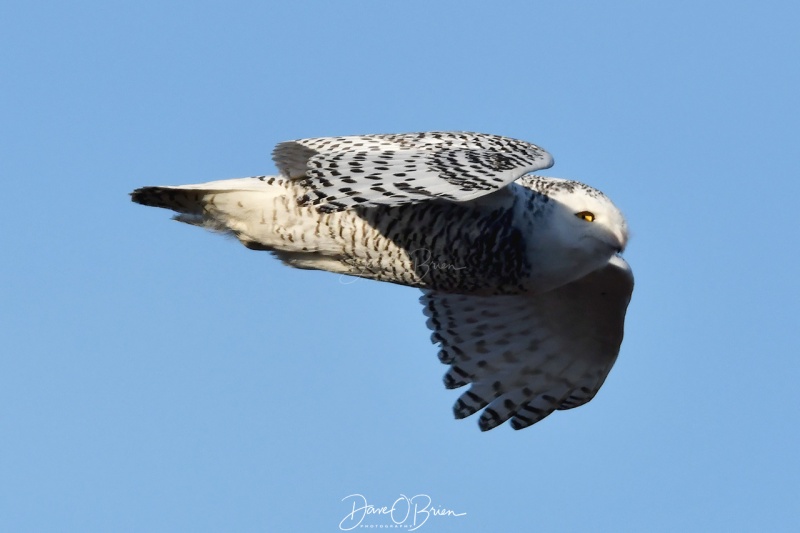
[{"xmin": 132, "ymin": 132, "xmax": 633, "ymax": 431}]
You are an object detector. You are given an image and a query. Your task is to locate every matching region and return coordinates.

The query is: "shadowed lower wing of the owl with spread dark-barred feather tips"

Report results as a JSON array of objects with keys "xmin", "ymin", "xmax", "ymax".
[{"xmin": 421, "ymin": 256, "xmax": 633, "ymax": 431}]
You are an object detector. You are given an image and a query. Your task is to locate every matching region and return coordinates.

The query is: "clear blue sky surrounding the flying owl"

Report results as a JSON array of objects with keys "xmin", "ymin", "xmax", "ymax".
[{"xmin": 0, "ymin": 0, "xmax": 800, "ymax": 532}]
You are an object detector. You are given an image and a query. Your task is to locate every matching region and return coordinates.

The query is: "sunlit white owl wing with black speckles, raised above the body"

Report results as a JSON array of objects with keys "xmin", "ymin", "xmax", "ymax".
[{"xmin": 272, "ymin": 132, "xmax": 553, "ymax": 211}]
